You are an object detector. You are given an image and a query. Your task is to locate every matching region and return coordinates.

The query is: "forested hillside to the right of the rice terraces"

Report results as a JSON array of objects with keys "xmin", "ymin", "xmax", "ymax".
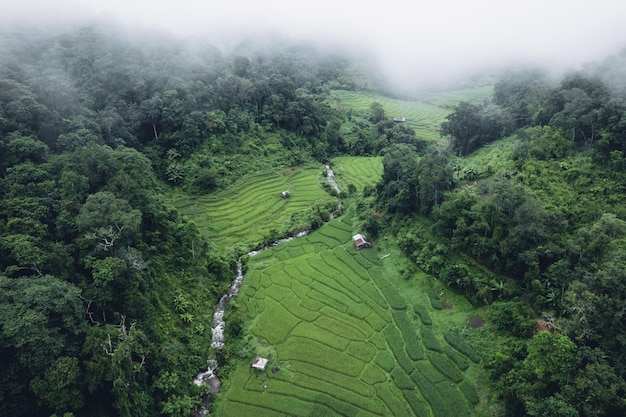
[{"xmin": 370, "ymin": 62, "xmax": 626, "ymax": 416}]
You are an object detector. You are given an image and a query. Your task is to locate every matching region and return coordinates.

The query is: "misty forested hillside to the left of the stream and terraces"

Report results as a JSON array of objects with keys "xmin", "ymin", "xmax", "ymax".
[{"xmin": 0, "ymin": 27, "xmax": 360, "ymax": 416}]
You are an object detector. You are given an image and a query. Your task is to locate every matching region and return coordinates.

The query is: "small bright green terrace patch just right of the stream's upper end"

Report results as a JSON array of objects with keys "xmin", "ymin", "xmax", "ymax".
[{"xmin": 331, "ymin": 156, "xmax": 383, "ymax": 192}]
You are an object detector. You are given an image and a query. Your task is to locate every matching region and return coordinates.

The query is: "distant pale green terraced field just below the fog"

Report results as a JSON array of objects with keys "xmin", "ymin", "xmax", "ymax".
[{"xmin": 331, "ymin": 86, "xmax": 493, "ymax": 141}]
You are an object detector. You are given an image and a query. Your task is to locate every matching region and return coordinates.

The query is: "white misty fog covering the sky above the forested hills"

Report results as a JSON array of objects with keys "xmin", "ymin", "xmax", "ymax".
[{"xmin": 0, "ymin": 0, "xmax": 626, "ymax": 93}]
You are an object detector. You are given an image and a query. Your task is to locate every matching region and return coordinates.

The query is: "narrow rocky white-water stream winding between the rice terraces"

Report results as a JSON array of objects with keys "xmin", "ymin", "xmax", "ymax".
[{"xmin": 193, "ymin": 165, "xmax": 341, "ymax": 416}]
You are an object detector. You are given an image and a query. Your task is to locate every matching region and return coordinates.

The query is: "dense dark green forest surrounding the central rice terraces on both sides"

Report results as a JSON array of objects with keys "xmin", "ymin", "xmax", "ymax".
[{"xmin": 0, "ymin": 21, "xmax": 626, "ymax": 416}]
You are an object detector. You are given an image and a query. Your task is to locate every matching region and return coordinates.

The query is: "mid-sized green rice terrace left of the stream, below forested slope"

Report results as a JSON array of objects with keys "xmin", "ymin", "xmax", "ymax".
[{"xmin": 174, "ymin": 166, "xmax": 333, "ymax": 250}]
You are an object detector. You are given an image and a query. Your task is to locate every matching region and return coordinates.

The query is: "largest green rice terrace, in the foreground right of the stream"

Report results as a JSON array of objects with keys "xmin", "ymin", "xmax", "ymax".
[{"xmin": 215, "ymin": 209, "xmax": 478, "ymax": 417}]
